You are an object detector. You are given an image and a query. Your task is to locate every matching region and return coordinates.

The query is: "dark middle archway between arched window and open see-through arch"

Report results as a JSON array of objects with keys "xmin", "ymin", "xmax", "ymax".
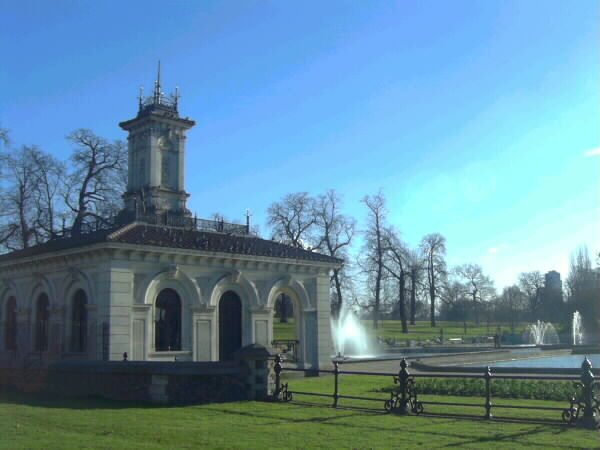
[{"xmin": 219, "ymin": 291, "xmax": 242, "ymax": 361}]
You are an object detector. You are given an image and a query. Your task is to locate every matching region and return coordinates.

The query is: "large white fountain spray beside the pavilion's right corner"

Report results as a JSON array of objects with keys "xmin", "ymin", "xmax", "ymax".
[{"xmin": 331, "ymin": 305, "xmax": 372, "ymax": 358}]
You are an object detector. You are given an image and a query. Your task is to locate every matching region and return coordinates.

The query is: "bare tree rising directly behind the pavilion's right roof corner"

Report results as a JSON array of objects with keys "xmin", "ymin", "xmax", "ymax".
[{"xmin": 313, "ymin": 189, "xmax": 356, "ymax": 316}]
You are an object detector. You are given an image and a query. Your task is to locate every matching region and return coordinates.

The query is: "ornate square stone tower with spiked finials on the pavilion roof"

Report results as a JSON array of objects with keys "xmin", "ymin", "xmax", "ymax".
[{"xmin": 119, "ymin": 62, "xmax": 195, "ymax": 216}]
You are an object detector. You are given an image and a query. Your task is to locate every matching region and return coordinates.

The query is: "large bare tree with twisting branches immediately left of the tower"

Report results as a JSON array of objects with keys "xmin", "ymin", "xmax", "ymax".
[{"xmin": 64, "ymin": 129, "xmax": 127, "ymax": 234}]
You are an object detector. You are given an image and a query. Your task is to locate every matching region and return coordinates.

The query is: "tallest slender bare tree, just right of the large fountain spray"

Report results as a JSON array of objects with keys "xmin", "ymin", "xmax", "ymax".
[{"xmin": 359, "ymin": 191, "xmax": 387, "ymax": 328}]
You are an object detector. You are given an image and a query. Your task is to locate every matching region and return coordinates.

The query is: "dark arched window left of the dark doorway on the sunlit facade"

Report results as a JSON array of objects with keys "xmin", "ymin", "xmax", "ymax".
[{"xmin": 154, "ymin": 289, "xmax": 181, "ymax": 352}]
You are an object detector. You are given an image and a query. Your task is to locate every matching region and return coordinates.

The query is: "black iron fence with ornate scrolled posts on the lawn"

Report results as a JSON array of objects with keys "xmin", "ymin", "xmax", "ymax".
[{"xmin": 273, "ymin": 355, "xmax": 600, "ymax": 428}]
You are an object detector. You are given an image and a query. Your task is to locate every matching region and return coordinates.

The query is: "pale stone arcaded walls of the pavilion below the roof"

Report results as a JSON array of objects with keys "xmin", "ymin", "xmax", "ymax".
[{"xmin": 0, "ymin": 239, "xmax": 334, "ymax": 367}]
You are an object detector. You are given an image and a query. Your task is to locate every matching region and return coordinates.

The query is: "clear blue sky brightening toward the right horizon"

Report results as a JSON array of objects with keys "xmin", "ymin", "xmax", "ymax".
[{"xmin": 0, "ymin": 0, "xmax": 600, "ymax": 288}]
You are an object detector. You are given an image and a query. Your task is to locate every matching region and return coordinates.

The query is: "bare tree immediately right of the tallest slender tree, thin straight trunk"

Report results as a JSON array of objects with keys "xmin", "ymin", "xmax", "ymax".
[{"xmin": 383, "ymin": 229, "xmax": 409, "ymax": 333}]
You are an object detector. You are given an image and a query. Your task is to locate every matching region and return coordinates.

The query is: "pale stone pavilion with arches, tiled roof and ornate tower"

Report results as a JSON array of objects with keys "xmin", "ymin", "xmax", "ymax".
[{"xmin": 0, "ymin": 72, "xmax": 342, "ymax": 367}]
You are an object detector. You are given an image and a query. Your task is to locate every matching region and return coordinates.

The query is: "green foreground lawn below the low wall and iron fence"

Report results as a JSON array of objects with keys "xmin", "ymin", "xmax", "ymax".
[{"xmin": 0, "ymin": 376, "xmax": 600, "ymax": 449}]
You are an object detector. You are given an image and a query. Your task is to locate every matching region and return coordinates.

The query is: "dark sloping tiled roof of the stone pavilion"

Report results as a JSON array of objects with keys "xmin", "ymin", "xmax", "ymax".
[{"xmin": 0, "ymin": 224, "xmax": 343, "ymax": 264}]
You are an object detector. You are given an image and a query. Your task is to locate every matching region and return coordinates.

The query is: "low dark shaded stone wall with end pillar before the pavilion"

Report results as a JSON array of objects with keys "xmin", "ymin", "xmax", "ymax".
[{"xmin": 0, "ymin": 344, "xmax": 273, "ymax": 404}]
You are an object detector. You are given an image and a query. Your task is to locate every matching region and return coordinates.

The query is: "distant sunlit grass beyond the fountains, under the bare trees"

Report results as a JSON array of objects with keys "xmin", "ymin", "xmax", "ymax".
[{"xmin": 273, "ymin": 318, "xmax": 527, "ymax": 344}]
